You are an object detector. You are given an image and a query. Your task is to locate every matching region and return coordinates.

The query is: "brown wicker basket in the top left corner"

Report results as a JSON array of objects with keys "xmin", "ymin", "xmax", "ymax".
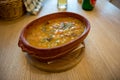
[{"xmin": 0, "ymin": 0, "xmax": 25, "ymax": 20}]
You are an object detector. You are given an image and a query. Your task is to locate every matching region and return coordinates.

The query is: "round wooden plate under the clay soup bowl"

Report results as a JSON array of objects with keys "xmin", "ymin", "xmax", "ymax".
[{"xmin": 26, "ymin": 43, "xmax": 85, "ymax": 72}]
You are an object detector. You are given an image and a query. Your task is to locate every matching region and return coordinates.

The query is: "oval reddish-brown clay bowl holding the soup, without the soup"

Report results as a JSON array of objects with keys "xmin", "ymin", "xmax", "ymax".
[{"xmin": 18, "ymin": 12, "xmax": 90, "ymax": 61}]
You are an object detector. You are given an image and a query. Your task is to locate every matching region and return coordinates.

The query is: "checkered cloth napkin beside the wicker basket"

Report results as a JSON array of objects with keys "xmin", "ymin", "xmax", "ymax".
[{"xmin": 23, "ymin": 0, "xmax": 43, "ymax": 15}]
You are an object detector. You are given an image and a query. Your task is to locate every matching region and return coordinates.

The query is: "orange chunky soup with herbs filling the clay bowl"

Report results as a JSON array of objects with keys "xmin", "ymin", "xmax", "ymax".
[{"xmin": 25, "ymin": 17, "xmax": 85, "ymax": 48}]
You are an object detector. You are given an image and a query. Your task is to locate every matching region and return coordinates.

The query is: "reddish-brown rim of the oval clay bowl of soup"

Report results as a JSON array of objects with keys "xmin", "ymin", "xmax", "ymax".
[{"xmin": 20, "ymin": 12, "xmax": 90, "ymax": 50}]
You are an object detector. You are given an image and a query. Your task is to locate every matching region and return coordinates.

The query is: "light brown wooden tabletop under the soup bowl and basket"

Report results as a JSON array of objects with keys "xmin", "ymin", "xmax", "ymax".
[{"xmin": 0, "ymin": 0, "xmax": 120, "ymax": 80}]
